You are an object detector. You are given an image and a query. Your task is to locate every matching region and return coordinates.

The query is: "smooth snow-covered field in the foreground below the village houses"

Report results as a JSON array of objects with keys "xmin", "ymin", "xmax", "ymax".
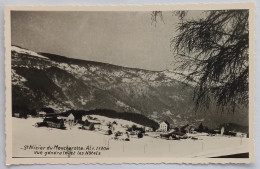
[{"xmin": 12, "ymin": 118, "xmax": 249, "ymax": 158}]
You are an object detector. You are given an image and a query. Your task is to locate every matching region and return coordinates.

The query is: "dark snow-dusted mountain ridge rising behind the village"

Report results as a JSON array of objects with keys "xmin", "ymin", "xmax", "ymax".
[{"xmin": 11, "ymin": 46, "xmax": 248, "ymax": 129}]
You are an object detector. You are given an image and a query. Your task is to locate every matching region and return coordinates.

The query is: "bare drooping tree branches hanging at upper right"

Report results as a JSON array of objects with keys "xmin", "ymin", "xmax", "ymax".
[{"xmin": 153, "ymin": 10, "xmax": 249, "ymax": 112}]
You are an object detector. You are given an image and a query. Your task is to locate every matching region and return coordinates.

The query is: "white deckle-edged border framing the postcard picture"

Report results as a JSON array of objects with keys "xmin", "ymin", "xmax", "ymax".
[{"xmin": 5, "ymin": 2, "xmax": 255, "ymax": 165}]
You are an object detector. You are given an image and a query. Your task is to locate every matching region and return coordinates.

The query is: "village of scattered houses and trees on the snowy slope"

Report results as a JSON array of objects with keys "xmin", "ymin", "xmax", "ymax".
[{"xmin": 14, "ymin": 109, "xmax": 249, "ymax": 141}]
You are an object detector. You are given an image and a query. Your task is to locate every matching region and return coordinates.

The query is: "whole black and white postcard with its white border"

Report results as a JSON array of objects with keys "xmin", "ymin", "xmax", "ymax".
[{"xmin": 6, "ymin": 3, "xmax": 254, "ymax": 164}]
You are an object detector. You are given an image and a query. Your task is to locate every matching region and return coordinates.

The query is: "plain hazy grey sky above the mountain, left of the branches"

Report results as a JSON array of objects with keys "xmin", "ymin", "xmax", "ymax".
[{"xmin": 11, "ymin": 11, "xmax": 181, "ymax": 70}]
